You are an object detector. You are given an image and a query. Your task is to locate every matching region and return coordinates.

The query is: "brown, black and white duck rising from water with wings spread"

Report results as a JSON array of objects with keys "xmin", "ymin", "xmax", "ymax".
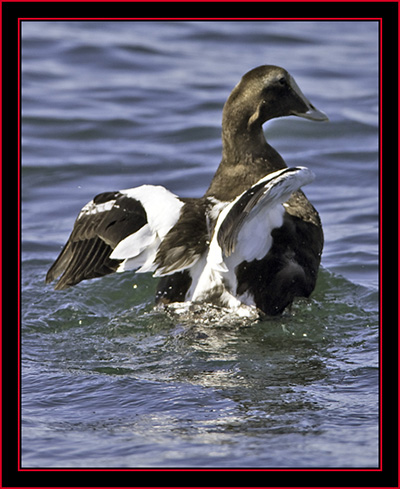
[{"xmin": 46, "ymin": 65, "xmax": 328, "ymax": 316}]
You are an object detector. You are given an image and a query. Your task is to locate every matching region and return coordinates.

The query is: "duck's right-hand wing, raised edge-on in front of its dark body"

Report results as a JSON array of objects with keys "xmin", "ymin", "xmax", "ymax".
[{"xmin": 216, "ymin": 167, "xmax": 314, "ymax": 256}]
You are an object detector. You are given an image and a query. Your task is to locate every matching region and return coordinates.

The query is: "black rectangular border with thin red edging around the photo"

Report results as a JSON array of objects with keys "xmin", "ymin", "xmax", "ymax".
[{"xmin": 2, "ymin": 1, "xmax": 398, "ymax": 487}]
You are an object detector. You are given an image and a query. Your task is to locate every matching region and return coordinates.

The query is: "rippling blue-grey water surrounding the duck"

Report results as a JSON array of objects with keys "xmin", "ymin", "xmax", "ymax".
[{"xmin": 21, "ymin": 22, "xmax": 379, "ymax": 468}]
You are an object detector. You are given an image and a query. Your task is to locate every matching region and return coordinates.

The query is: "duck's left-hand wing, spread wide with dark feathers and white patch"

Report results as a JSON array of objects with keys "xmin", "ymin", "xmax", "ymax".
[{"xmin": 46, "ymin": 185, "xmax": 183, "ymax": 289}]
